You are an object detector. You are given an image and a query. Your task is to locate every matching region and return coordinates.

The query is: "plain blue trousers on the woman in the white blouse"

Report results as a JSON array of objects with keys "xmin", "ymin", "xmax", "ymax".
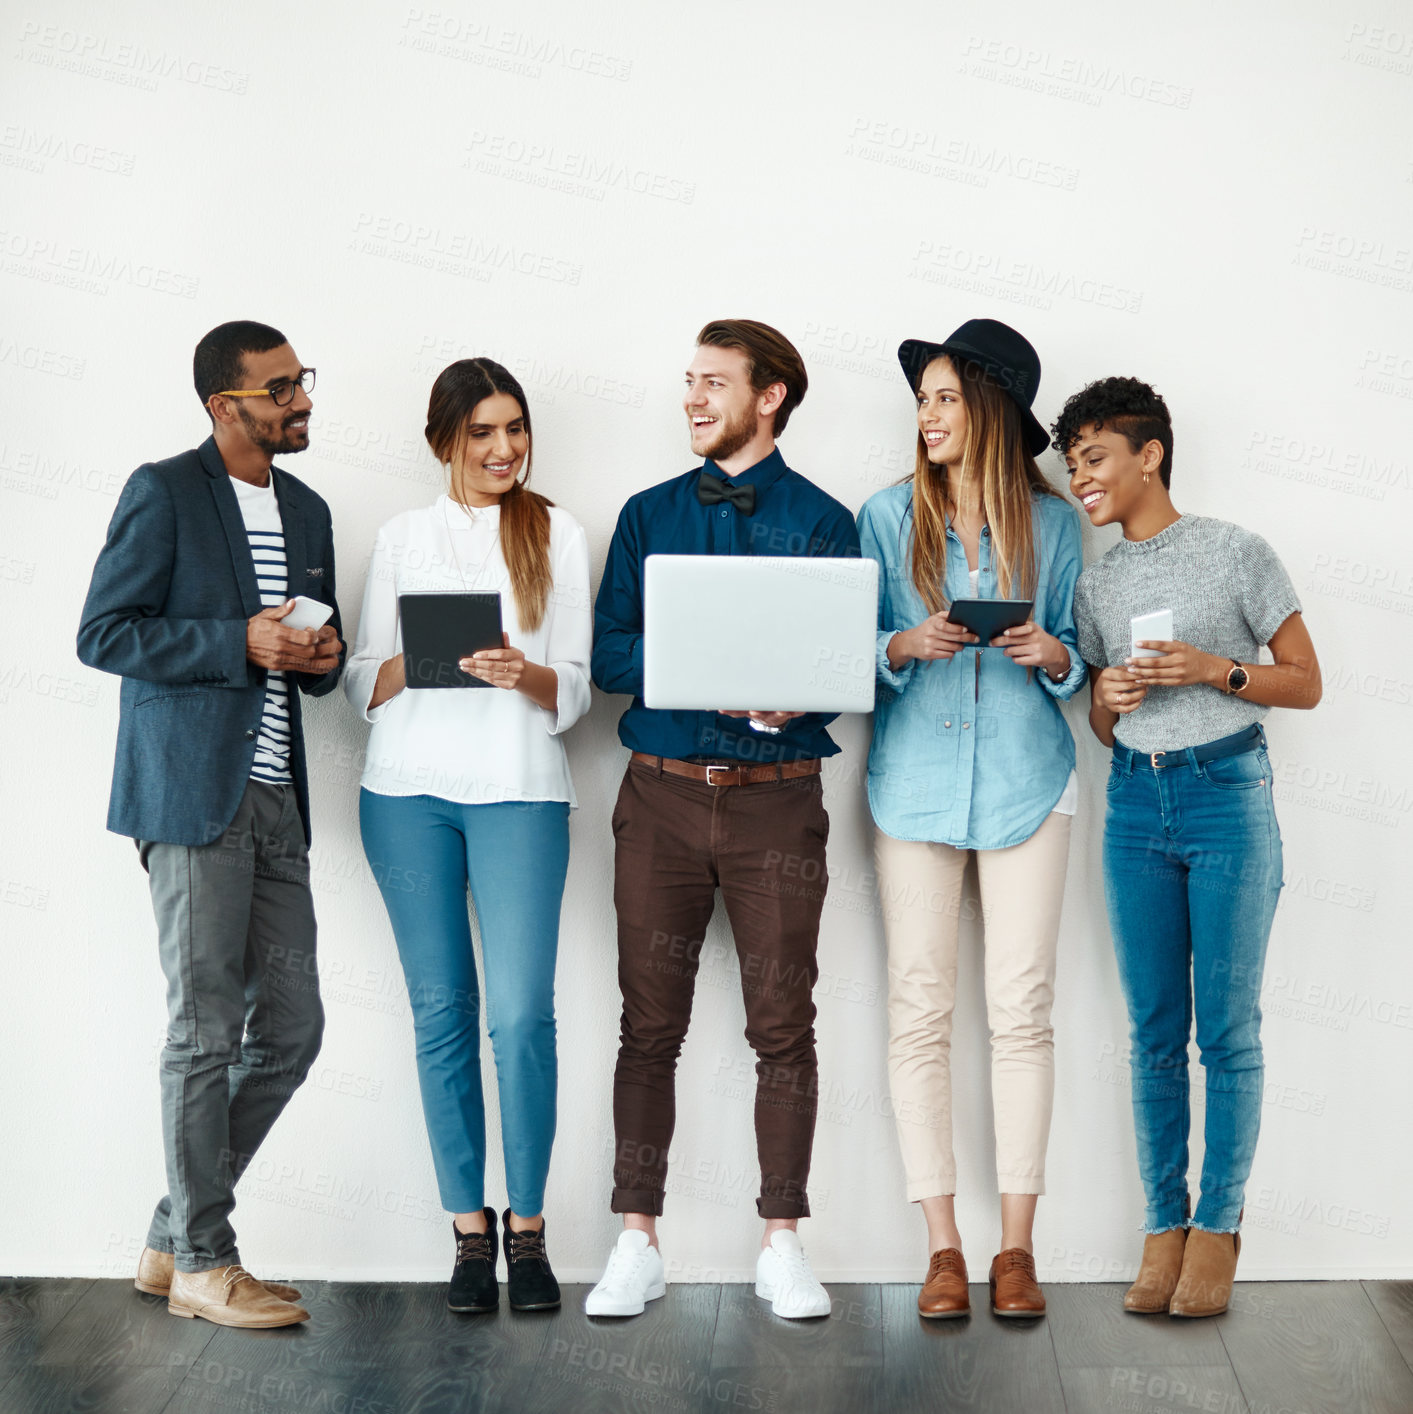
[{"xmin": 358, "ymin": 790, "xmax": 569, "ymax": 1217}]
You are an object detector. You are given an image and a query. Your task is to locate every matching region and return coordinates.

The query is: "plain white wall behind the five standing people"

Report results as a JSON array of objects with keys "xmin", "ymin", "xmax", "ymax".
[{"xmin": 0, "ymin": 0, "xmax": 1413, "ymax": 1280}]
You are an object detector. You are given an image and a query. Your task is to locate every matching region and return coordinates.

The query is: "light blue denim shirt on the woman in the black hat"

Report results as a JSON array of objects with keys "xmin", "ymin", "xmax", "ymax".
[{"xmin": 859, "ymin": 482, "xmax": 1085, "ymax": 850}]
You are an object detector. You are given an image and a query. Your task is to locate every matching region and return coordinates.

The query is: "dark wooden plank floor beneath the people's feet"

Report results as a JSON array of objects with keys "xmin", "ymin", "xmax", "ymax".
[{"xmin": 0, "ymin": 1278, "xmax": 1413, "ymax": 1414}]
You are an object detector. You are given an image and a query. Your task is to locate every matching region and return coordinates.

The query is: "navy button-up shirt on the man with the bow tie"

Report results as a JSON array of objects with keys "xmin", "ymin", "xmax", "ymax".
[{"xmin": 593, "ymin": 450, "xmax": 859, "ymax": 762}]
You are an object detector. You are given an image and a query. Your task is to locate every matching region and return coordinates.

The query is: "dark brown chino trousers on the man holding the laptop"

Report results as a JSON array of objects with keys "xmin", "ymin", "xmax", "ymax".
[{"xmin": 612, "ymin": 761, "xmax": 829, "ymax": 1217}]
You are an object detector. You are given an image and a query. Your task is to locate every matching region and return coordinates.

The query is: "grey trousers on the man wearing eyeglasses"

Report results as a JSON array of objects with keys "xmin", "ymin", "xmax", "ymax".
[{"xmin": 137, "ymin": 781, "xmax": 324, "ymax": 1271}]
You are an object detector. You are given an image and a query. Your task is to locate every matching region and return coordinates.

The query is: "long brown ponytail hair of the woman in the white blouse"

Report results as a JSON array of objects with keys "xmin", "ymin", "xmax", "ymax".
[{"xmin": 426, "ymin": 358, "xmax": 554, "ymax": 629}]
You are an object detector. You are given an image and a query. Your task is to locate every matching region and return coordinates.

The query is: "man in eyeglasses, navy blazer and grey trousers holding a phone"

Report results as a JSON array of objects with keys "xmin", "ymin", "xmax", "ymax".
[{"xmin": 78, "ymin": 320, "xmax": 344, "ymax": 1326}]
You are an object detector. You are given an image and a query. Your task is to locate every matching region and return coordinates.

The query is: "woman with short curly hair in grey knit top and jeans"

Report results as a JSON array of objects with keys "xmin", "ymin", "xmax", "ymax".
[{"xmin": 1054, "ymin": 378, "xmax": 1320, "ymax": 1316}]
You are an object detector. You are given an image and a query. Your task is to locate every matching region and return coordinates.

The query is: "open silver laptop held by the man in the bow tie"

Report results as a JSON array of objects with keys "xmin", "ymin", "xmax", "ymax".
[{"xmin": 642, "ymin": 554, "xmax": 878, "ymax": 711}]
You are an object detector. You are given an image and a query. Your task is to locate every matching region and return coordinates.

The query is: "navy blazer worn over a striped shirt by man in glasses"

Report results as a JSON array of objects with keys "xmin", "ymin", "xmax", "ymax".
[{"xmin": 78, "ymin": 437, "xmax": 344, "ymax": 844}]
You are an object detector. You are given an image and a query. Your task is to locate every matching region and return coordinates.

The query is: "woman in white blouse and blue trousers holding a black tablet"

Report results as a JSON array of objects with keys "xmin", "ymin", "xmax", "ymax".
[{"xmin": 344, "ymin": 359, "xmax": 591, "ymax": 1311}]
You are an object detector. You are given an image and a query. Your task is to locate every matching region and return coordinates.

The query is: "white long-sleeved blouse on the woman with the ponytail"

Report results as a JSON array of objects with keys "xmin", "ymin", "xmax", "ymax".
[{"xmin": 344, "ymin": 495, "xmax": 593, "ymax": 806}]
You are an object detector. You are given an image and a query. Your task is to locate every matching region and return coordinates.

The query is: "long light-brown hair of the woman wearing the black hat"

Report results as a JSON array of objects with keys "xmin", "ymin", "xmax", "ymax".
[{"xmin": 911, "ymin": 355, "xmax": 1059, "ymax": 614}]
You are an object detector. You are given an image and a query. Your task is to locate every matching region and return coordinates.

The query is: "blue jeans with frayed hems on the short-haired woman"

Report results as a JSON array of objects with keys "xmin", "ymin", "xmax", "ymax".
[{"xmin": 1103, "ymin": 734, "xmax": 1281, "ymax": 1233}]
